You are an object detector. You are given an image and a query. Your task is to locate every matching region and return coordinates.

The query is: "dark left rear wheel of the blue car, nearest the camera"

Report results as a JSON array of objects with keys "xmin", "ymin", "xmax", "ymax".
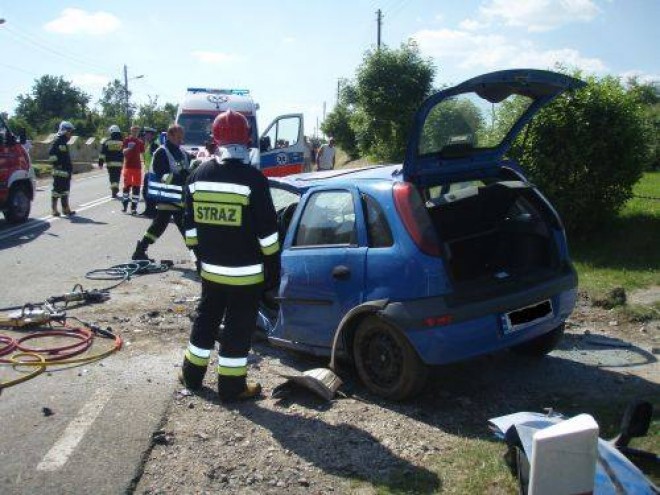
[{"xmin": 353, "ymin": 316, "xmax": 428, "ymax": 401}]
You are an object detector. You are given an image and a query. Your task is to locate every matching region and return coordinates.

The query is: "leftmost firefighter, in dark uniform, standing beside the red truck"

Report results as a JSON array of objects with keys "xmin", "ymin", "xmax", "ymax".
[{"xmin": 48, "ymin": 120, "xmax": 76, "ymax": 217}]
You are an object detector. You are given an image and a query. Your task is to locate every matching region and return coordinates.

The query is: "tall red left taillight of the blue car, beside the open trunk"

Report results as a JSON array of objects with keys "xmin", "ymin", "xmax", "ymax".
[{"xmin": 394, "ymin": 182, "xmax": 442, "ymax": 256}]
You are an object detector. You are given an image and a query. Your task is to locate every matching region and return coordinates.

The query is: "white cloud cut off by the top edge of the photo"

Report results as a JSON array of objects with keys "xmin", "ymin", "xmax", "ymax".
[{"xmin": 479, "ymin": 0, "xmax": 601, "ymax": 31}]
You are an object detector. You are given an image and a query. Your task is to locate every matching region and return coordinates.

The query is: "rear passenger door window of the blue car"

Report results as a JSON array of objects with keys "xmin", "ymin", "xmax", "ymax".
[{"xmin": 293, "ymin": 191, "xmax": 357, "ymax": 247}]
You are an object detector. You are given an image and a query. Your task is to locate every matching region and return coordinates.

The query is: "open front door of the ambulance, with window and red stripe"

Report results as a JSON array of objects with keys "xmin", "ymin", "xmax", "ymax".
[{"xmin": 259, "ymin": 113, "xmax": 311, "ymax": 177}]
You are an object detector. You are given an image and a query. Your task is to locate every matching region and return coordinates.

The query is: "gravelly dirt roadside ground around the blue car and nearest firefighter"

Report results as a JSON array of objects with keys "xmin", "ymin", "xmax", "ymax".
[{"xmin": 68, "ymin": 274, "xmax": 660, "ymax": 494}]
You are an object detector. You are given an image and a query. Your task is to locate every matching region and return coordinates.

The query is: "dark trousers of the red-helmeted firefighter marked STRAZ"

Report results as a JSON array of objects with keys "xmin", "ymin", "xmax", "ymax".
[{"xmin": 190, "ymin": 279, "xmax": 261, "ymax": 397}]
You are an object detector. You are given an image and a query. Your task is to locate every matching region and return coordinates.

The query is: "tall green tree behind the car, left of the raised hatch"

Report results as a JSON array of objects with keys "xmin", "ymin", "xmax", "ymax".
[{"xmin": 351, "ymin": 41, "xmax": 435, "ymax": 161}]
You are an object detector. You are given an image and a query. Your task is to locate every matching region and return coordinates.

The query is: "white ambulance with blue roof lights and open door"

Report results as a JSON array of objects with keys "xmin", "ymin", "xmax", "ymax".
[{"xmin": 176, "ymin": 88, "xmax": 311, "ymax": 177}]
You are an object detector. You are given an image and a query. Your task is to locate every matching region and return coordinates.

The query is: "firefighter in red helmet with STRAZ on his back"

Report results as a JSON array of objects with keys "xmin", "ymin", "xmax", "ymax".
[{"xmin": 179, "ymin": 110, "xmax": 280, "ymax": 401}]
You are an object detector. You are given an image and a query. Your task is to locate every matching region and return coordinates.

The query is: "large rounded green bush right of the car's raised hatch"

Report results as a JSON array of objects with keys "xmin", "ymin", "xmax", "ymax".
[{"xmin": 510, "ymin": 74, "xmax": 649, "ymax": 235}]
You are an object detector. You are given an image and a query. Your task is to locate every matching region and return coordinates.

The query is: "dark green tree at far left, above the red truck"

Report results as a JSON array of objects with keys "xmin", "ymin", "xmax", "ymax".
[{"xmin": 15, "ymin": 75, "xmax": 90, "ymax": 133}]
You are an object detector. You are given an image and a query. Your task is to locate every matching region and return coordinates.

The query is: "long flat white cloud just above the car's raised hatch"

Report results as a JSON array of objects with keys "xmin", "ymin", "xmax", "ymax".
[{"xmin": 413, "ymin": 29, "xmax": 607, "ymax": 72}]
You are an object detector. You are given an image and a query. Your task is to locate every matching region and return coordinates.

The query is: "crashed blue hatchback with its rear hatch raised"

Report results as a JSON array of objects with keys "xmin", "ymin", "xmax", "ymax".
[{"xmin": 259, "ymin": 69, "xmax": 583, "ymax": 400}]
